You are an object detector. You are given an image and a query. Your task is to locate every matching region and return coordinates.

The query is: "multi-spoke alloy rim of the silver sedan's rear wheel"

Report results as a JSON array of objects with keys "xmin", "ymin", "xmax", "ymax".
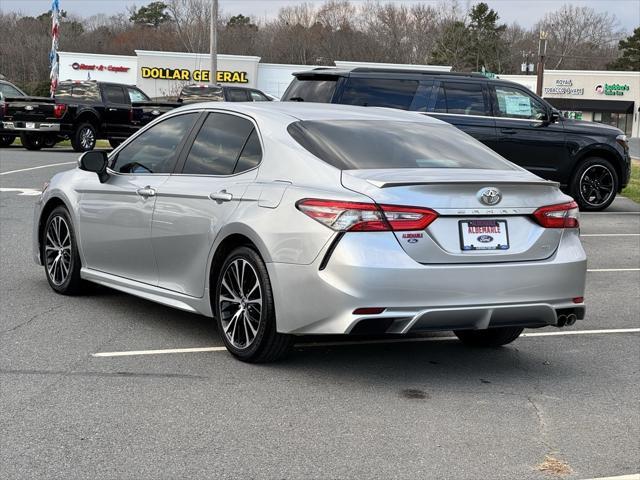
[{"xmin": 218, "ymin": 258, "xmax": 262, "ymax": 349}]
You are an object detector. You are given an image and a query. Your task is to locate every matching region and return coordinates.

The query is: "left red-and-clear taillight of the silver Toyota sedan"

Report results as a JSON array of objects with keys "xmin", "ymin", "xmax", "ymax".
[{"xmin": 296, "ymin": 198, "xmax": 438, "ymax": 232}]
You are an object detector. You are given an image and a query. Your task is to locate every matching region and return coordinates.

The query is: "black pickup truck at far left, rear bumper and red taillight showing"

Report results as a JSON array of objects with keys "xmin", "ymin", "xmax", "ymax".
[{"xmin": 2, "ymin": 81, "xmax": 162, "ymax": 152}]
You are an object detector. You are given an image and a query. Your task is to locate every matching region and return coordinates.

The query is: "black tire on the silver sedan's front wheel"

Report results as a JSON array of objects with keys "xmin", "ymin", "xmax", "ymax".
[{"xmin": 40, "ymin": 206, "xmax": 85, "ymax": 295}]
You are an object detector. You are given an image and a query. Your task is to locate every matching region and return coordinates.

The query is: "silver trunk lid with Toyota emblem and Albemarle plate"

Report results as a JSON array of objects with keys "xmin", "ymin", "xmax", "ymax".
[{"xmin": 342, "ymin": 168, "xmax": 570, "ymax": 264}]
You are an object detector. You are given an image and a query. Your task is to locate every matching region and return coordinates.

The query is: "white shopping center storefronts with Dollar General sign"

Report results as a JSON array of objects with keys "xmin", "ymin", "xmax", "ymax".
[{"xmin": 59, "ymin": 50, "xmax": 640, "ymax": 137}]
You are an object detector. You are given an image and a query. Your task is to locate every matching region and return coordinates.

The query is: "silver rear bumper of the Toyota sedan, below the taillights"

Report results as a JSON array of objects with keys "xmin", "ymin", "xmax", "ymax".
[{"xmin": 267, "ymin": 231, "xmax": 586, "ymax": 334}]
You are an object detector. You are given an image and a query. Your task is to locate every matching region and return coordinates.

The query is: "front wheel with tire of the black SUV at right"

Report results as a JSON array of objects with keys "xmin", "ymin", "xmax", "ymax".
[{"xmin": 570, "ymin": 157, "xmax": 619, "ymax": 211}]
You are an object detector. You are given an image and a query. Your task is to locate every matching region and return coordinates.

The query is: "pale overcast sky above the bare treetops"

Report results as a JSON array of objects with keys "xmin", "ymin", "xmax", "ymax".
[{"xmin": 0, "ymin": 0, "xmax": 640, "ymax": 32}]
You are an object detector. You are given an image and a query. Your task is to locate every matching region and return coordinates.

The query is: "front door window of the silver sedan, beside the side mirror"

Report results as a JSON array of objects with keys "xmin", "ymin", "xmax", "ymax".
[{"xmin": 111, "ymin": 113, "xmax": 200, "ymax": 174}]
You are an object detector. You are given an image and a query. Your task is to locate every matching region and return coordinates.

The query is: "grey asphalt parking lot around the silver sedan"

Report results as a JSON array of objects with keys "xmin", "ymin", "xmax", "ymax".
[{"xmin": 0, "ymin": 147, "xmax": 640, "ymax": 479}]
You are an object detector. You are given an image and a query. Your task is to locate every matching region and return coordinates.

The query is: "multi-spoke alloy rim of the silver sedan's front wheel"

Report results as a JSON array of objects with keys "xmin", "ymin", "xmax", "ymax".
[{"xmin": 44, "ymin": 215, "xmax": 72, "ymax": 286}]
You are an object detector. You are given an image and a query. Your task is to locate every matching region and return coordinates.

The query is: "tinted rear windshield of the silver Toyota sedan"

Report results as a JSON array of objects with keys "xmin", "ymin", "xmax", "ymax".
[{"xmin": 287, "ymin": 120, "xmax": 518, "ymax": 170}]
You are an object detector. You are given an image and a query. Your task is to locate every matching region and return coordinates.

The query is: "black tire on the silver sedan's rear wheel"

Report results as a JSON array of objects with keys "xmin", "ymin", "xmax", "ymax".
[{"xmin": 211, "ymin": 247, "xmax": 292, "ymax": 363}]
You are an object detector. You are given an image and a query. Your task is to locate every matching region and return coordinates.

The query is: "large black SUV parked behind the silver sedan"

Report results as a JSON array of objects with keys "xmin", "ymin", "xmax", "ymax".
[{"xmin": 282, "ymin": 68, "xmax": 631, "ymax": 210}]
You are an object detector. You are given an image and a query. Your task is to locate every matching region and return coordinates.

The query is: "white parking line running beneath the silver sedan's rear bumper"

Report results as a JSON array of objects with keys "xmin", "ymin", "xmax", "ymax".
[{"xmin": 91, "ymin": 328, "xmax": 640, "ymax": 357}]
